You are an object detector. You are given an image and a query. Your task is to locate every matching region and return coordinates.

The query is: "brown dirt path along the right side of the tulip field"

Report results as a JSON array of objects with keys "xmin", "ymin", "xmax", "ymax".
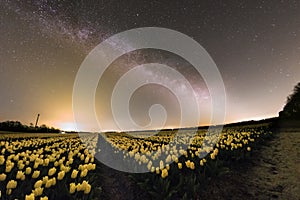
[{"xmin": 211, "ymin": 130, "xmax": 300, "ymax": 200}]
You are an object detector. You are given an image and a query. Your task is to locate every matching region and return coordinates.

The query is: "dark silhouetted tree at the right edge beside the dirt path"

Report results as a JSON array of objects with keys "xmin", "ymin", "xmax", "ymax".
[{"xmin": 279, "ymin": 82, "xmax": 300, "ymax": 120}]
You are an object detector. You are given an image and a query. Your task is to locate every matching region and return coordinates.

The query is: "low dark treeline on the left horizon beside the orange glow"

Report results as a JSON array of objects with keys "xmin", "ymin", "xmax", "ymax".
[{"xmin": 0, "ymin": 121, "xmax": 60, "ymax": 133}]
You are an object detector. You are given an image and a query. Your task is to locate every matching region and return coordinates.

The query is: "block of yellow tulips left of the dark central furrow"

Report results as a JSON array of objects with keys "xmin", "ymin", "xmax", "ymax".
[{"xmin": 0, "ymin": 134, "xmax": 96, "ymax": 200}]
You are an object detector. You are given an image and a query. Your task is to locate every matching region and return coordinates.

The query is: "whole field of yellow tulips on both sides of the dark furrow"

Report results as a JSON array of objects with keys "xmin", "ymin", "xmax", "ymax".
[{"xmin": 0, "ymin": 124, "xmax": 272, "ymax": 199}]
